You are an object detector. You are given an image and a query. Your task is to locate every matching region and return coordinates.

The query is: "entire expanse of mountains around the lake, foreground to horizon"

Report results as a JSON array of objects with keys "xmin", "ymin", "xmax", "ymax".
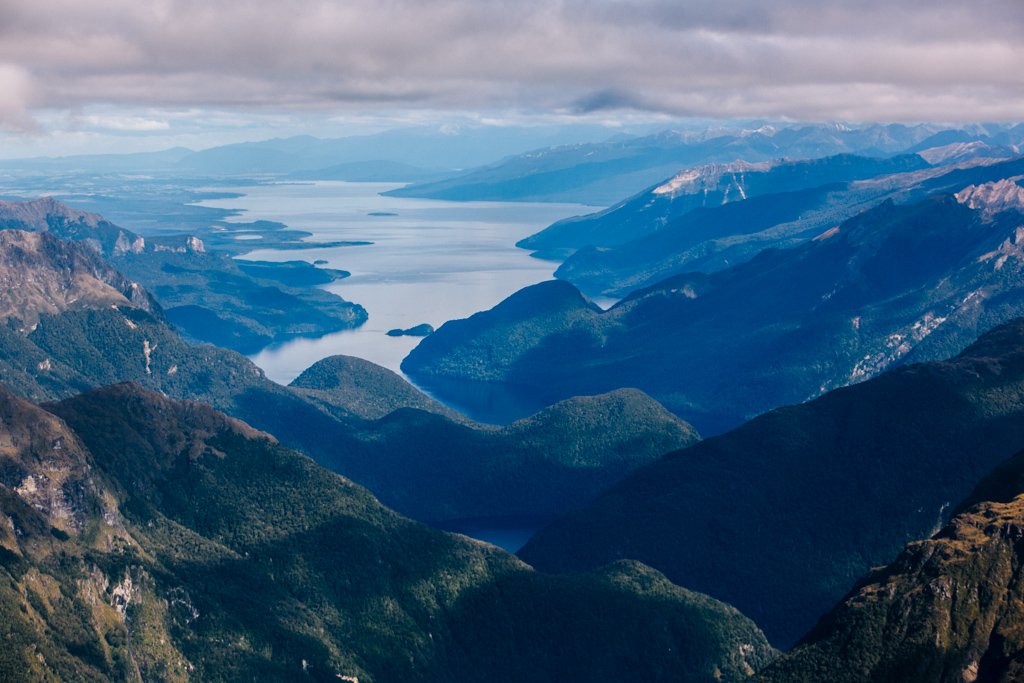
[{"xmin": 9, "ymin": 125, "xmax": 1024, "ymax": 683}]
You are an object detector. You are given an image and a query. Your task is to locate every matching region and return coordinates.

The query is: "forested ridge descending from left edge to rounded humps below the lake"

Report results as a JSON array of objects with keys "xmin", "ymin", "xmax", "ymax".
[{"xmin": 0, "ymin": 232, "xmax": 696, "ymax": 521}]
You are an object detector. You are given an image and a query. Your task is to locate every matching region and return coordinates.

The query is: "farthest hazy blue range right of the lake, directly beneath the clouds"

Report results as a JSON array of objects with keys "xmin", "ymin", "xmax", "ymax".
[{"xmin": 388, "ymin": 125, "xmax": 1024, "ymax": 206}]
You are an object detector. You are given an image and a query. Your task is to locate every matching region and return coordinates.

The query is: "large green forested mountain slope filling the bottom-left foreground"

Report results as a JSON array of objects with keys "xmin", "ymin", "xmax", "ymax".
[{"xmin": 0, "ymin": 384, "xmax": 773, "ymax": 683}]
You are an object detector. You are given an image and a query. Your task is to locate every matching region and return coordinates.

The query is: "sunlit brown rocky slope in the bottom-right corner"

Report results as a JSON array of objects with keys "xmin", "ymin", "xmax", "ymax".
[{"xmin": 756, "ymin": 475, "xmax": 1024, "ymax": 683}]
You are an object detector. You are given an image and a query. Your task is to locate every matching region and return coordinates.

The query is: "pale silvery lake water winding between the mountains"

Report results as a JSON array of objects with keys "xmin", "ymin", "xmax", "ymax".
[{"xmin": 195, "ymin": 181, "xmax": 594, "ymax": 384}]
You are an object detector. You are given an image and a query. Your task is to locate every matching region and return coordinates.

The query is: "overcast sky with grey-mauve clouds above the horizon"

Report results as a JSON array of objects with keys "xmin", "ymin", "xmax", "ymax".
[{"xmin": 0, "ymin": 0, "xmax": 1024, "ymax": 157}]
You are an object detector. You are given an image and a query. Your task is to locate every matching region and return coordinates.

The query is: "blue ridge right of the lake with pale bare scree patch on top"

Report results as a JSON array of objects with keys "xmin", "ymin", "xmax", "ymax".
[{"xmin": 519, "ymin": 155, "xmax": 1024, "ymax": 298}]
